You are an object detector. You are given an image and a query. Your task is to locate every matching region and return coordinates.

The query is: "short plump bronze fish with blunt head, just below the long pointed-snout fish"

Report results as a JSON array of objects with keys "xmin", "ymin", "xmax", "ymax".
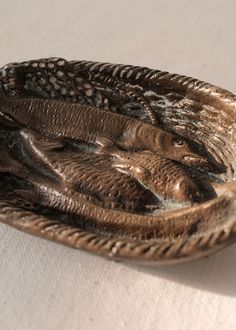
[{"xmin": 106, "ymin": 150, "xmax": 201, "ymax": 202}]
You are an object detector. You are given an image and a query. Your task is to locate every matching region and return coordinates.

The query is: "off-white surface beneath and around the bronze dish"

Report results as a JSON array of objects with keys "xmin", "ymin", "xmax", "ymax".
[{"xmin": 0, "ymin": 0, "xmax": 236, "ymax": 330}]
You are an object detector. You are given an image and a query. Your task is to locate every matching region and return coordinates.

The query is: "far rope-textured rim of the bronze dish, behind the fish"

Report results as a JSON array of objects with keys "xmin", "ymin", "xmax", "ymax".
[{"xmin": 0, "ymin": 57, "xmax": 236, "ymax": 108}]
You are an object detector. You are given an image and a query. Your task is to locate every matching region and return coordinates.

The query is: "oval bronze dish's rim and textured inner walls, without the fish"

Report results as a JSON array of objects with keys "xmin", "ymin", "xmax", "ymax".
[{"xmin": 0, "ymin": 58, "xmax": 236, "ymax": 263}]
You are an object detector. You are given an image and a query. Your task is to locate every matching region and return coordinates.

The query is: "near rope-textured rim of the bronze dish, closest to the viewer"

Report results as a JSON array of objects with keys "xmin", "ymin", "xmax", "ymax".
[{"xmin": 0, "ymin": 202, "xmax": 236, "ymax": 264}]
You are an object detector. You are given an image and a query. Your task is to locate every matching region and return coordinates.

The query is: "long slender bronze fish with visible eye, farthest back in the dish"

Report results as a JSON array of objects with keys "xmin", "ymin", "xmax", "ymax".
[{"xmin": 0, "ymin": 95, "xmax": 218, "ymax": 169}]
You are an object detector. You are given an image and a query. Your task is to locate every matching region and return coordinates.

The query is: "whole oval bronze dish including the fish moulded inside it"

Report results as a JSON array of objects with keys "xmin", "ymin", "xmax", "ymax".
[{"xmin": 0, "ymin": 58, "xmax": 236, "ymax": 263}]
